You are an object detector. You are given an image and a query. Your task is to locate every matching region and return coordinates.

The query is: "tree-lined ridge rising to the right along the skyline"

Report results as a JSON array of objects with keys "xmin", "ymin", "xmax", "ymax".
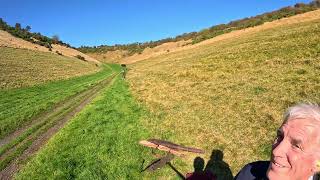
[{"xmin": 77, "ymin": 0, "xmax": 320, "ymax": 59}]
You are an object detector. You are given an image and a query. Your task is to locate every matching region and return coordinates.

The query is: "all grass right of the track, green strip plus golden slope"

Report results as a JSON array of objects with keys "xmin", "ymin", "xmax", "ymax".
[{"xmin": 1, "ymin": 13, "xmax": 320, "ymax": 179}]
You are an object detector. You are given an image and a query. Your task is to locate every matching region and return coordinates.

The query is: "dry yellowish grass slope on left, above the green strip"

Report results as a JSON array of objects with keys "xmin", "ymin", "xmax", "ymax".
[{"xmin": 0, "ymin": 47, "xmax": 99, "ymax": 89}]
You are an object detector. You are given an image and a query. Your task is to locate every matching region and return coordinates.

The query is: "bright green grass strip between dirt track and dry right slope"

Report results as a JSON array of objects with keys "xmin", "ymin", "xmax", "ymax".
[{"xmin": 16, "ymin": 76, "xmax": 159, "ymax": 179}]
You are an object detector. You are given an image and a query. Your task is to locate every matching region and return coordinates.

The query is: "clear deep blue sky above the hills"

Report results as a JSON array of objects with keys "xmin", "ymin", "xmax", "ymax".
[{"xmin": 0, "ymin": 0, "xmax": 311, "ymax": 47}]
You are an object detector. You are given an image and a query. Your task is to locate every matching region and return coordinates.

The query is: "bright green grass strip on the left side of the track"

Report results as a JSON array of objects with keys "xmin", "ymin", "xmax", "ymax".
[{"xmin": 0, "ymin": 65, "xmax": 113, "ymax": 139}]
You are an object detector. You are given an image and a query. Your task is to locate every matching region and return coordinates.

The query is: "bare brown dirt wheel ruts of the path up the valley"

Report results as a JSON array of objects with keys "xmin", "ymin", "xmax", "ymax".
[{"xmin": 0, "ymin": 74, "xmax": 117, "ymax": 180}]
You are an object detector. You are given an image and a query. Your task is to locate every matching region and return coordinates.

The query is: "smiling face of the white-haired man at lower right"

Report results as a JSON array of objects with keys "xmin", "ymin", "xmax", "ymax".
[{"xmin": 267, "ymin": 119, "xmax": 320, "ymax": 180}]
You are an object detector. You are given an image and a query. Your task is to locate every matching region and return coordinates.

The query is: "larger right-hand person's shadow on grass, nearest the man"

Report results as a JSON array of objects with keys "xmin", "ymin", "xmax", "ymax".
[{"xmin": 204, "ymin": 149, "xmax": 233, "ymax": 180}]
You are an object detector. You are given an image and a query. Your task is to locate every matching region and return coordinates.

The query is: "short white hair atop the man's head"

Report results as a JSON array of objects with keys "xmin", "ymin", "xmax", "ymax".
[{"xmin": 284, "ymin": 103, "xmax": 320, "ymax": 125}]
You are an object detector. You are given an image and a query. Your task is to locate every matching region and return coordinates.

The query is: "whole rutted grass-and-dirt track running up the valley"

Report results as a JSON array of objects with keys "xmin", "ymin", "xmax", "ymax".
[{"xmin": 0, "ymin": 66, "xmax": 119, "ymax": 178}]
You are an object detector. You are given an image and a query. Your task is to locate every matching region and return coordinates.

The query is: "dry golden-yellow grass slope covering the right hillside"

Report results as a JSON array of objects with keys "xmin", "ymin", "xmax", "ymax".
[{"xmin": 127, "ymin": 17, "xmax": 320, "ymax": 175}]
